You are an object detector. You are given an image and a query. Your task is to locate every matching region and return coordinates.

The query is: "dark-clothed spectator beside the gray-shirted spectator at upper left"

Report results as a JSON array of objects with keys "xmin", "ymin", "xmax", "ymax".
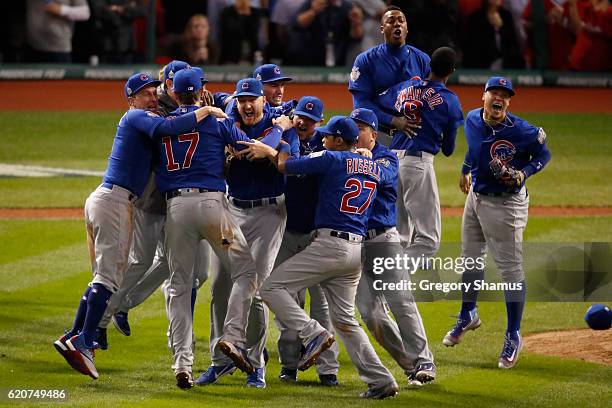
[{"xmin": 90, "ymin": 0, "xmax": 147, "ymax": 64}]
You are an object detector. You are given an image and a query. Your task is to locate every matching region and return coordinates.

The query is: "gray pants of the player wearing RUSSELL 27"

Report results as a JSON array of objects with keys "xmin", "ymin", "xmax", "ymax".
[{"xmin": 260, "ymin": 228, "xmax": 395, "ymax": 388}]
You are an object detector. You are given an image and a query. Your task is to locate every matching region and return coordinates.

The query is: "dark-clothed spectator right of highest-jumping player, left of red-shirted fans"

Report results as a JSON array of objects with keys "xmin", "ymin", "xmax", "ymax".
[{"xmin": 463, "ymin": 0, "xmax": 525, "ymax": 70}]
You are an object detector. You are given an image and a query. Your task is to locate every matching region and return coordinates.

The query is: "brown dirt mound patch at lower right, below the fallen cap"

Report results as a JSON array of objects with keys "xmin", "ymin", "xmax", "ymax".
[{"xmin": 523, "ymin": 329, "xmax": 612, "ymax": 365}]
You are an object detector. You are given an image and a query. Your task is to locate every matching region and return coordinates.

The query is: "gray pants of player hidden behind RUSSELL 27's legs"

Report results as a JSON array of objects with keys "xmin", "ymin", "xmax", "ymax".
[{"xmin": 274, "ymin": 230, "xmax": 340, "ymax": 375}]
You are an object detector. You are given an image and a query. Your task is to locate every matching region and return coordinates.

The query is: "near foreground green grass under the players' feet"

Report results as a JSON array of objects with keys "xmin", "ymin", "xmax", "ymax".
[{"xmin": 0, "ymin": 217, "xmax": 612, "ymax": 408}]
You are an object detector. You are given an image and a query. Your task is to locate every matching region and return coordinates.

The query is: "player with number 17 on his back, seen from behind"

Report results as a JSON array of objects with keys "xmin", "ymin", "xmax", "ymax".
[{"xmin": 157, "ymin": 69, "xmax": 292, "ymax": 388}]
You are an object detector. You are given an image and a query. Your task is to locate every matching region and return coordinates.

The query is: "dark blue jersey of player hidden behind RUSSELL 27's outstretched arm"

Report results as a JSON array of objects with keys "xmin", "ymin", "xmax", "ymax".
[{"xmin": 285, "ymin": 131, "xmax": 323, "ymax": 234}]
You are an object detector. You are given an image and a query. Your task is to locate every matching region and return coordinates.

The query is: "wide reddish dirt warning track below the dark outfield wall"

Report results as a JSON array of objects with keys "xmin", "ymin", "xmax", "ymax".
[{"xmin": 0, "ymin": 80, "xmax": 612, "ymax": 113}]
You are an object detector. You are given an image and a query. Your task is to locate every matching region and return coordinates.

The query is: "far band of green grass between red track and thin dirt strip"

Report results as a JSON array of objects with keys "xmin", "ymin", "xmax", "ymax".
[{"xmin": 0, "ymin": 112, "xmax": 612, "ymax": 208}]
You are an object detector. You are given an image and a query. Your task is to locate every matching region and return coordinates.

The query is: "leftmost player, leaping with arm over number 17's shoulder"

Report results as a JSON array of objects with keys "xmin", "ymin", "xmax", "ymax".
[{"xmin": 54, "ymin": 73, "xmax": 215, "ymax": 379}]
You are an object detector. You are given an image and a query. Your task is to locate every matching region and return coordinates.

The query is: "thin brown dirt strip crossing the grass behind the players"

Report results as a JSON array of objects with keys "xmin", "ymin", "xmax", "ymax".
[{"xmin": 0, "ymin": 207, "xmax": 612, "ymax": 219}]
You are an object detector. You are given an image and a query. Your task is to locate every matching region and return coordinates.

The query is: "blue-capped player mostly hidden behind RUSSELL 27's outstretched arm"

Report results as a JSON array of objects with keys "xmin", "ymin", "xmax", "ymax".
[{"xmin": 272, "ymin": 95, "xmax": 339, "ymax": 386}]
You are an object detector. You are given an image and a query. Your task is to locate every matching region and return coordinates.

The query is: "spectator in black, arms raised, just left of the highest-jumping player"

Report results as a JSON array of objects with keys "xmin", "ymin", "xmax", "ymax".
[{"xmin": 296, "ymin": 0, "xmax": 363, "ymax": 66}]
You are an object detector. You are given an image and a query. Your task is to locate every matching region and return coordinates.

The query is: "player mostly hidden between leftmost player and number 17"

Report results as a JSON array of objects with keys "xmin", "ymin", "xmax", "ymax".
[{"xmin": 97, "ymin": 60, "xmax": 211, "ymax": 350}]
